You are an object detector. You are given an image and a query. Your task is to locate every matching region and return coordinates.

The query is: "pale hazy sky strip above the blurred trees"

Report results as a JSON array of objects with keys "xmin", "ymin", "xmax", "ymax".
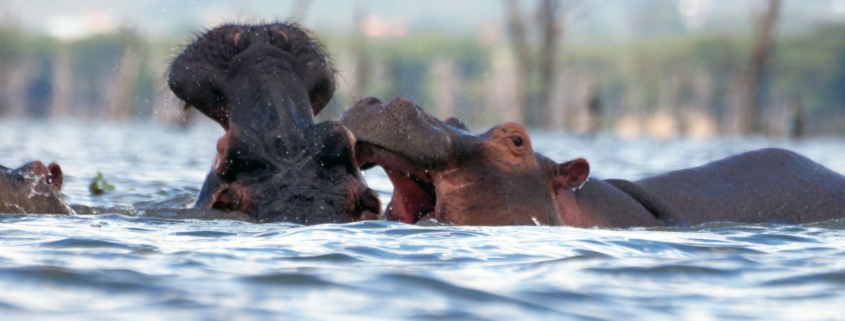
[{"xmin": 0, "ymin": 0, "xmax": 845, "ymax": 40}]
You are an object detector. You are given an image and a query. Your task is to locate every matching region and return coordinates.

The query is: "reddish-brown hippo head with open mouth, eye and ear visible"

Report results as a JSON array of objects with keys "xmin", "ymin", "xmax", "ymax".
[{"xmin": 341, "ymin": 98, "xmax": 590, "ymax": 225}]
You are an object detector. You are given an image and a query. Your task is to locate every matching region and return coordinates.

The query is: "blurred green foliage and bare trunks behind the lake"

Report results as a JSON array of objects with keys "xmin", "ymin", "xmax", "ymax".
[{"xmin": 0, "ymin": 0, "xmax": 845, "ymax": 138}]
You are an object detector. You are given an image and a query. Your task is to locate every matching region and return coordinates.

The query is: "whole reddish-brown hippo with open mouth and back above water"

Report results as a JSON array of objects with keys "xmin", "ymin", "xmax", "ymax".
[{"xmin": 341, "ymin": 98, "xmax": 845, "ymax": 227}]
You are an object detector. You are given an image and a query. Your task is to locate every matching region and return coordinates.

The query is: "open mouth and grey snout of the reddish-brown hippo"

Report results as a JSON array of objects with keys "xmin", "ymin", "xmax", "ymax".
[{"xmin": 341, "ymin": 98, "xmax": 479, "ymax": 224}]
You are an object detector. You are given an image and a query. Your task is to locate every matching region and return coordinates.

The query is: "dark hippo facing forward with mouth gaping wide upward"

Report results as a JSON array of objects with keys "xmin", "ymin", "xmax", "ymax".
[{"xmin": 168, "ymin": 22, "xmax": 381, "ymax": 224}]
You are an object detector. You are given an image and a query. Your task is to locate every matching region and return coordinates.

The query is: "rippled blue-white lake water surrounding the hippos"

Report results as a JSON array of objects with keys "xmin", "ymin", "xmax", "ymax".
[{"xmin": 0, "ymin": 121, "xmax": 845, "ymax": 320}]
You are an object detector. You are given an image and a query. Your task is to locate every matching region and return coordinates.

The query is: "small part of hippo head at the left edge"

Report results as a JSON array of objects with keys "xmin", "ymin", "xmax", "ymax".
[{"xmin": 0, "ymin": 161, "xmax": 73, "ymax": 214}]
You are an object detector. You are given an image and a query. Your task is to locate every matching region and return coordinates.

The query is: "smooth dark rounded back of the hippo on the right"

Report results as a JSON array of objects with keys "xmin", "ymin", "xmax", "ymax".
[{"xmin": 632, "ymin": 148, "xmax": 845, "ymax": 224}]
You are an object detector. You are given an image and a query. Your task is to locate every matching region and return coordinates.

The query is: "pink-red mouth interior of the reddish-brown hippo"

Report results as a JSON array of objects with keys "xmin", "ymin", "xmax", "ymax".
[{"xmin": 355, "ymin": 141, "xmax": 437, "ymax": 224}]
